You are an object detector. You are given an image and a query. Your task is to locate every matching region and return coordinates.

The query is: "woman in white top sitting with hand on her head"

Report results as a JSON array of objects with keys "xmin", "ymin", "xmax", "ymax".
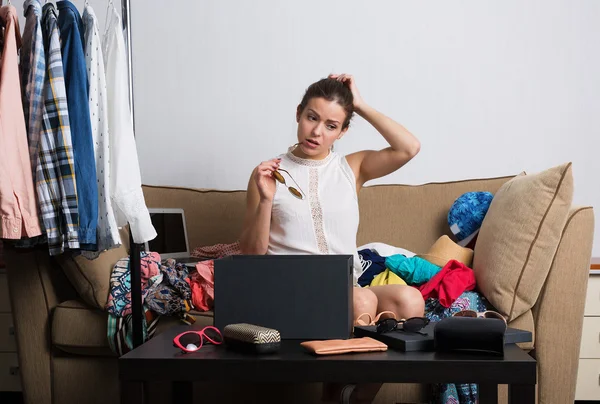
[{"xmin": 240, "ymin": 74, "xmax": 424, "ymax": 324}]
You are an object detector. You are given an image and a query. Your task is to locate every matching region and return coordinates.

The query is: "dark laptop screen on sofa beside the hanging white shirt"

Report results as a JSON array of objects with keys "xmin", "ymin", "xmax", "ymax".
[{"xmin": 146, "ymin": 209, "xmax": 189, "ymax": 259}]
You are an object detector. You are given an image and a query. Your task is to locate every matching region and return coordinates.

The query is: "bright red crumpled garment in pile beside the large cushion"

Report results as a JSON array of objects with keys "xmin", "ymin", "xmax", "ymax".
[{"xmin": 419, "ymin": 260, "xmax": 475, "ymax": 307}]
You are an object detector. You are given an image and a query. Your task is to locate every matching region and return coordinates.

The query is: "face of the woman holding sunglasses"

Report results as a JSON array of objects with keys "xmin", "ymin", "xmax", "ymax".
[{"xmin": 296, "ymin": 97, "xmax": 348, "ymax": 160}]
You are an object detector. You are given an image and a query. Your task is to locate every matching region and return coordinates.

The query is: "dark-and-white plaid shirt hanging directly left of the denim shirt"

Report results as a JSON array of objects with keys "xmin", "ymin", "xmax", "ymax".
[{"xmin": 36, "ymin": 3, "xmax": 79, "ymax": 255}]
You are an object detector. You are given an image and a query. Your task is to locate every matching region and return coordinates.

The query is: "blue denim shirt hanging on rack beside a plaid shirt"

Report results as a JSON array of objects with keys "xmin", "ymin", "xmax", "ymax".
[{"xmin": 56, "ymin": 0, "xmax": 98, "ymax": 251}]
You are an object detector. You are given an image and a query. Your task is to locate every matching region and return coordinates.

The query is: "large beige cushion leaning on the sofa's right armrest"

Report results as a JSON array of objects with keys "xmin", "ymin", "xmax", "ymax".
[{"xmin": 473, "ymin": 163, "xmax": 573, "ymax": 321}]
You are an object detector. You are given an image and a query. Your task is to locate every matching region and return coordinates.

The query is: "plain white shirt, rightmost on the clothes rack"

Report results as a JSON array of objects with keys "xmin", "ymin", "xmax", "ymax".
[{"xmin": 102, "ymin": 5, "xmax": 156, "ymax": 244}]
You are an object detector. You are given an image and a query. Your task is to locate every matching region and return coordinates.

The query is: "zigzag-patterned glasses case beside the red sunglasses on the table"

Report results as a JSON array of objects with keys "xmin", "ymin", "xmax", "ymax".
[{"xmin": 223, "ymin": 323, "xmax": 281, "ymax": 354}]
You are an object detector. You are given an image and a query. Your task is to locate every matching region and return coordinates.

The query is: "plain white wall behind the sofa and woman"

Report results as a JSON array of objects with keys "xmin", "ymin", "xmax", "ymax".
[{"xmin": 15, "ymin": 0, "xmax": 600, "ymax": 256}]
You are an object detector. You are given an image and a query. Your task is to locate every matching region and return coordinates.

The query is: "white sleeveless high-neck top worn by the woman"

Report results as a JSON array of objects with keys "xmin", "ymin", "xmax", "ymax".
[{"xmin": 267, "ymin": 148, "xmax": 362, "ymax": 284}]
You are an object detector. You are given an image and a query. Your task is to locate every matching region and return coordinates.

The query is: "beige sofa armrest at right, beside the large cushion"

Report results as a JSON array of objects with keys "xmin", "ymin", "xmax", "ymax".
[{"xmin": 532, "ymin": 207, "xmax": 594, "ymax": 403}]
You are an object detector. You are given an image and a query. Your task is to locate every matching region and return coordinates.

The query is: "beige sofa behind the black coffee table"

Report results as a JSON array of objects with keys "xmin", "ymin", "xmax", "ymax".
[{"xmin": 5, "ymin": 168, "xmax": 594, "ymax": 404}]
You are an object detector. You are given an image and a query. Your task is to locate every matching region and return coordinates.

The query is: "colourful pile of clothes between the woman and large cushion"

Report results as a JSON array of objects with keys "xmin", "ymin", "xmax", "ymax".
[{"xmin": 358, "ymin": 192, "xmax": 493, "ymax": 404}]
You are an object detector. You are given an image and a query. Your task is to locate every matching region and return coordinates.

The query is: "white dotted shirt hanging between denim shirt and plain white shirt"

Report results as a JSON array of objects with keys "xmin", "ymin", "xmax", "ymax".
[{"xmin": 83, "ymin": 5, "xmax": 121, "ymax": 251}]
